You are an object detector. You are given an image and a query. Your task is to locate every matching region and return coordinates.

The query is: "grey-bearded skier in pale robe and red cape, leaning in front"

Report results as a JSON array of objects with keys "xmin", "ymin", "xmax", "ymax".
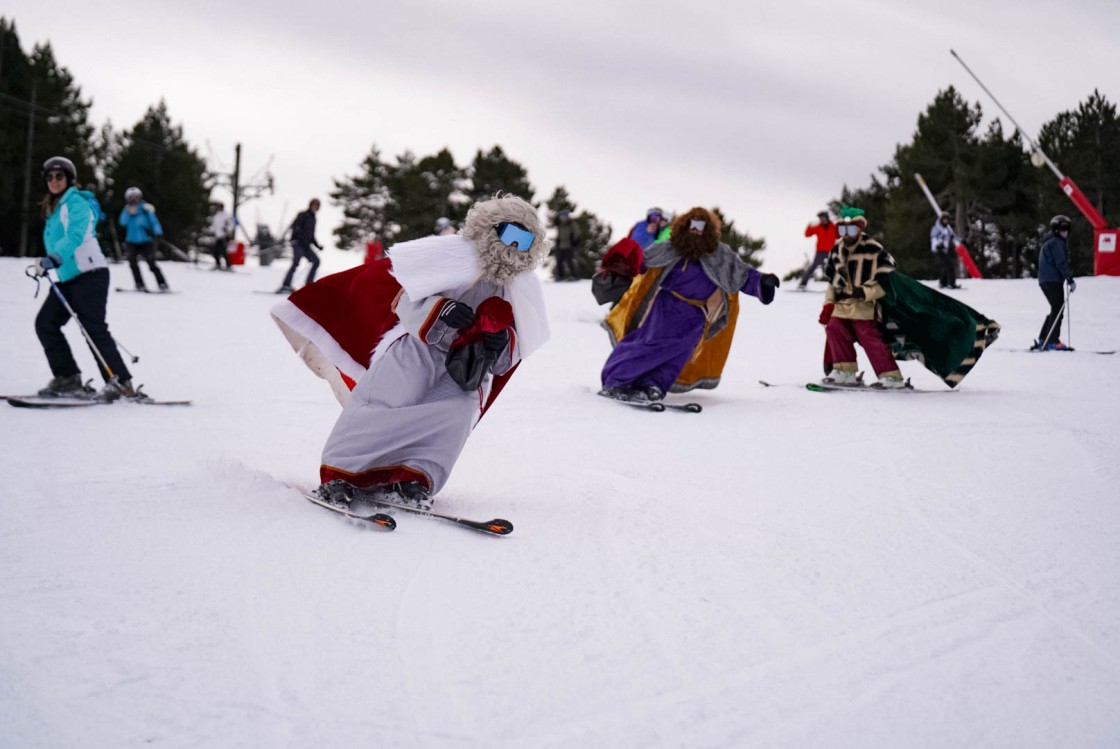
[{"xmin": 272, "ymin": 195, "xmax": 550, "ymax": 506}]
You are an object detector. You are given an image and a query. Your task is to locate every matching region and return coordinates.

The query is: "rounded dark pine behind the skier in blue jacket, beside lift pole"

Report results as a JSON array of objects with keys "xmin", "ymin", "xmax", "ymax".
[{"xmin": 102, "ymin": 101, "xmax": 209, "ymax": 253}]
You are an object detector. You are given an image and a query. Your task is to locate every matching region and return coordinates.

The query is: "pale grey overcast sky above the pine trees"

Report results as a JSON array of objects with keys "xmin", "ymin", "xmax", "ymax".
[{"xmin": 8, "ymin": 0, "xmax": 1120, "ymax": 272}]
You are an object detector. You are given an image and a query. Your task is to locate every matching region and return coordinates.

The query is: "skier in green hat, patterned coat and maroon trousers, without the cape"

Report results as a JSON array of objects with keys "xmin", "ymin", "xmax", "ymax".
[{"xmin": 819, "ymin": 207, "xmax": 906, "ymax": 388}]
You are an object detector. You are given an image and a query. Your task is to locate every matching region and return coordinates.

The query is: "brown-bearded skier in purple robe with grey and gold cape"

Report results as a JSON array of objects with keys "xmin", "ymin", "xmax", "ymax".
[{"xmin": 600, "ymin": 207, "xmax": 780, "ymax": 402}]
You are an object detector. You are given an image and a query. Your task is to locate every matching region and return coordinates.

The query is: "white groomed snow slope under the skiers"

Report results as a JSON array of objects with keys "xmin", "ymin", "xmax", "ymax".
[{"xmin": 0, "ymin": 253, "xmax": 1120, "ymax": 749}]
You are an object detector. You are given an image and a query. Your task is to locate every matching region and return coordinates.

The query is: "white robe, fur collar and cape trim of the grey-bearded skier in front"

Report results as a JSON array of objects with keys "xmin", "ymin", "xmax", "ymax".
[{"xmin": 273, "ymin": 231, "xmax": 549, "ymax": 494}]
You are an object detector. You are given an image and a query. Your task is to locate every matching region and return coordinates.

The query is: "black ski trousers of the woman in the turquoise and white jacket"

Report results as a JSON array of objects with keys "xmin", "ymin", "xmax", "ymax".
[{"xmin": 35, "ymin": 268, "xmax": 132, "ymax": 382}]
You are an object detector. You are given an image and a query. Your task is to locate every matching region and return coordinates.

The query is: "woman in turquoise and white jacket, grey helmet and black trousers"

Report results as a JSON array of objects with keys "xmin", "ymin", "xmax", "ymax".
[{"xmin": 35, "ymin": 156, "xmax": 134, "ymax": 400}]
